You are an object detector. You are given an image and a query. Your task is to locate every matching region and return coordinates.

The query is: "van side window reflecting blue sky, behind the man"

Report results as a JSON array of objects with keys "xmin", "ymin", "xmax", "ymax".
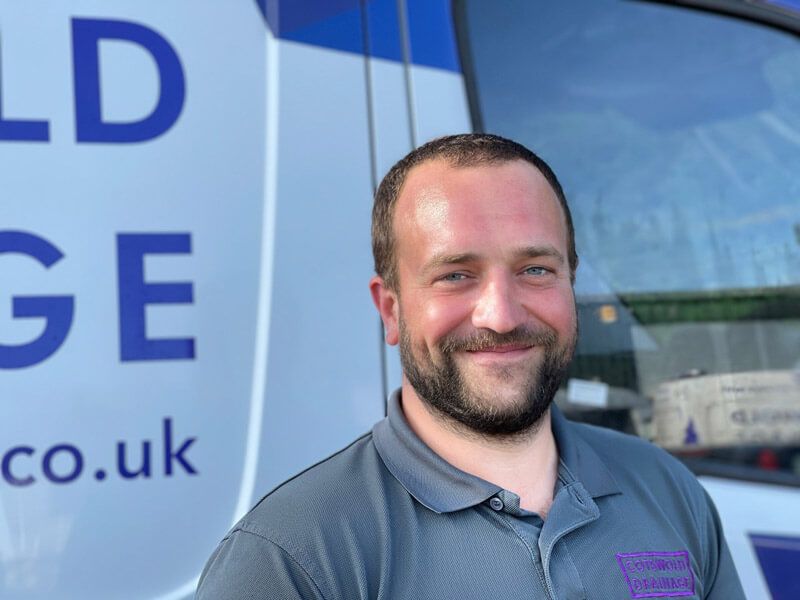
[{"xmin": 455, "ymin": 0, "xmax": 800, "ymax": 485}]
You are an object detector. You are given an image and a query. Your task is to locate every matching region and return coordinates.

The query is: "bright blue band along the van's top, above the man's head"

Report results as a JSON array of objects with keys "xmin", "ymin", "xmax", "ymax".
[{"xmin": 256, "ymin": 0, "xmax": 461, "ymax": 72}]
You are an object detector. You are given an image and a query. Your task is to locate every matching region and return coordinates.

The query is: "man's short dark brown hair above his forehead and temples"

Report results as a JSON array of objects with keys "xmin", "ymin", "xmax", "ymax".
[{"xmin": 372, "ymin": 133, "xmax": 578, "ymax": 290}]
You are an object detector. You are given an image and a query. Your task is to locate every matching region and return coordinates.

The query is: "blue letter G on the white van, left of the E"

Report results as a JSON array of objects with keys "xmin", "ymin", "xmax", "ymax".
[{"xmin": 0, "ymin": 231, "xmax": 75, "ymax": 369}]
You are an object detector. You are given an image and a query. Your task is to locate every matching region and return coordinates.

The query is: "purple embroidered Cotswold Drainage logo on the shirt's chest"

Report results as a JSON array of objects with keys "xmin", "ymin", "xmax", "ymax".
[{"xmin": 617, "ymin": 550, "xmax": 694, "ymax": 598}]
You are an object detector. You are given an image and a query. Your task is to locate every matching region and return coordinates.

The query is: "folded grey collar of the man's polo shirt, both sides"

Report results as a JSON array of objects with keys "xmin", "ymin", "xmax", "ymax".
[{"xmin": 372, "ymin": 390, "xmax": 621, "ymax": 513}]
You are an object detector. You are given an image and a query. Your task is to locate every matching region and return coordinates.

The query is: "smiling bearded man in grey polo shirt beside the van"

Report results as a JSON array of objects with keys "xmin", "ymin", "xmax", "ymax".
[{"xmin": 197, "ymin": 134, "xmax": 744, "ymax": 600}]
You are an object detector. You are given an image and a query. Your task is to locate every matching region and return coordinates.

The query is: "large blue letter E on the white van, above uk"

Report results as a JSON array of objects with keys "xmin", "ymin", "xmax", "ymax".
[{"xmin": 117, "ymin": 233, "xmax": 194, "ymax": 361}]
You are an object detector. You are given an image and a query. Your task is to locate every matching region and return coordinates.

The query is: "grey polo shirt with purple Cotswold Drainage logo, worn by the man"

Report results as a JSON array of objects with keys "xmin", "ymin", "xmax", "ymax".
[{"xmin": 196, "ymin": 392, "xmax": 744, "ymax": 600}]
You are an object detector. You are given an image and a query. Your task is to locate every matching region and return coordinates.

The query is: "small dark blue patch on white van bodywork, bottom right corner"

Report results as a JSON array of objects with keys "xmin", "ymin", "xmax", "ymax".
[{"xmin": 750, "ymin": 533, "xmax": 800, "ymax": 600}]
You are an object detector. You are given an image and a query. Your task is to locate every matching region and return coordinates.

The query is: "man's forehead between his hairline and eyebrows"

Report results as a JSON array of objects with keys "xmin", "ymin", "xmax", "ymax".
[{"xmin": 394, "ymin": 160, "xmax": 567, "ymax": 252}]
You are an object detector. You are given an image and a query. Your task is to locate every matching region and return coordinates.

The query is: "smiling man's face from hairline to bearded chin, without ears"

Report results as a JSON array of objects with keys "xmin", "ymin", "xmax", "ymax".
[{"xmin": 394, "ymin": 160, "xmax": 577, "ymax": 436}]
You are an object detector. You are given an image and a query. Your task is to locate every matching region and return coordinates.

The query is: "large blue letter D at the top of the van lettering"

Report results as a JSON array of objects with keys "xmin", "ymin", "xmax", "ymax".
[{"xmin": 72, "ymin": 19, "xmax": 186, "ymax": 144}]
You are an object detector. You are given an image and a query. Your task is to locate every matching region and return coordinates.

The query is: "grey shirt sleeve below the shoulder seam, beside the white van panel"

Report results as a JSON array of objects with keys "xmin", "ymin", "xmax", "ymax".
[{"xmin": 195, "ymin": 530, "xmax": 325, "ymax": 600}]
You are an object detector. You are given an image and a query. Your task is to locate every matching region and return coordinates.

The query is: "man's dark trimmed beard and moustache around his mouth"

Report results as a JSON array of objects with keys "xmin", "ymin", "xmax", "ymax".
[{"xmin": 400, "ymin": 323, "xmax": 577, "ymax": 438}]
